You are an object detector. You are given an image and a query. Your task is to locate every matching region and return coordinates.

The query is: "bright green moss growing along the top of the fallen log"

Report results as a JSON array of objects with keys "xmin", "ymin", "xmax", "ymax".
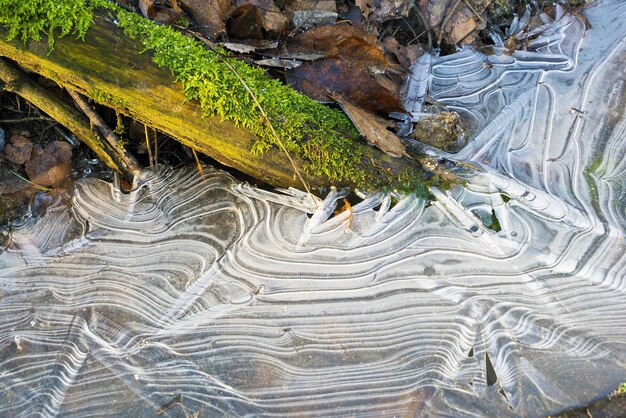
[{"xmin": 0, "ymin": 0, "xmax": 436, "ymax": 196}]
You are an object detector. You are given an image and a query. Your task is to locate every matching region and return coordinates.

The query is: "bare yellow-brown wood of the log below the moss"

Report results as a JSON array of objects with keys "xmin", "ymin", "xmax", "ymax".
[{"xmin": 0, "ymin": 17, "xmax": 421, "ymax": 188}]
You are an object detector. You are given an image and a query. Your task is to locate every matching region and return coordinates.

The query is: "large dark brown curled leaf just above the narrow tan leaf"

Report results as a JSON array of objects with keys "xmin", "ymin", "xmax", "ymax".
[{"xmin": 287, "ymin": 58, "xmax": 402, "ymax": 115}]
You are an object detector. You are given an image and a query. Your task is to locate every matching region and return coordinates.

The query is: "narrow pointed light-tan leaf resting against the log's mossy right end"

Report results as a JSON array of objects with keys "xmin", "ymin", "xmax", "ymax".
[{"xmin": 331, "ymin": 94, "xmax": 406, "ymax": 158}]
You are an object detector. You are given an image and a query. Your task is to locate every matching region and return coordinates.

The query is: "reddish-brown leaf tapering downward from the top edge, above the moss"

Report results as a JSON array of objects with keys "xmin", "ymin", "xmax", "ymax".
[{"xmin": 180, "ymin": 0, "xmax": 230, "ymax": 39}]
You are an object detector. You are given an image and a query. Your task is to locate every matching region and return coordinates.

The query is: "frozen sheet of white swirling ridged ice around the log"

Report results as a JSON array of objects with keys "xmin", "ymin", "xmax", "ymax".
[{"xmin": 0, "ymin": 1, "xmax": 626, "ymax": 417}]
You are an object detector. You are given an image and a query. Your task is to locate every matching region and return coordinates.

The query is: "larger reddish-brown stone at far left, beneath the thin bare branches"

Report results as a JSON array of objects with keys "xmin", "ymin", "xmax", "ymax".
[{"xmin": 25, "ymin": 141, "xmax": 72, "ymax": 186}]
